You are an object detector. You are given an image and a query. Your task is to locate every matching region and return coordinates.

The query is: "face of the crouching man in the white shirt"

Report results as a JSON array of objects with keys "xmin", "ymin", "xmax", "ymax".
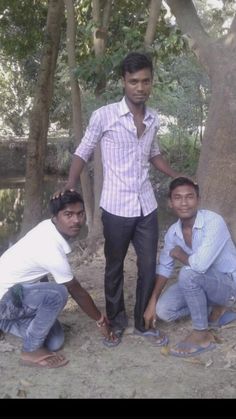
[{"xmin": 53, "ymin": 202, "xmax": 85, "ymax": 237}]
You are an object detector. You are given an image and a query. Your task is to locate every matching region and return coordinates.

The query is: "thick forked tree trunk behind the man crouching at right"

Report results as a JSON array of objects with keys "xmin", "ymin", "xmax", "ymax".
[{"xmin": 167, "ymin": 0, "xmax": 236, "ymax": 241}]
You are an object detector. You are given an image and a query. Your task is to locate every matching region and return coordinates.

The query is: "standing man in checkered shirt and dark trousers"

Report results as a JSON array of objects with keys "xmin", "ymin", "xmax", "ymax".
[{"xmin": 63, "ymin": 52, "xmax": 178, "ymax": 347}]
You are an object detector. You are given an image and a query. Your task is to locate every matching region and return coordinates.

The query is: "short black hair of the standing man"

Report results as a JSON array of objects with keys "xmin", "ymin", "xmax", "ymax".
[{"xmin": 121, "ymin": 52, "xmax": 153, "ymax": 77}]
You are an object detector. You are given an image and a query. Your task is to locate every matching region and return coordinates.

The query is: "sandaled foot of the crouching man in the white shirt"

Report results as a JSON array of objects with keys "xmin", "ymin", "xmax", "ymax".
[{"xmin": 20, "ymin": 348, "xmax": 69, "ymax": 368}]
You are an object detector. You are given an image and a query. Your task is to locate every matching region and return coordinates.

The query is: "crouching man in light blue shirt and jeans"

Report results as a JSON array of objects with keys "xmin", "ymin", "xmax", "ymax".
[{"xmin": 144, "ymin": 177, "xmax": 236, "ymax": 357}]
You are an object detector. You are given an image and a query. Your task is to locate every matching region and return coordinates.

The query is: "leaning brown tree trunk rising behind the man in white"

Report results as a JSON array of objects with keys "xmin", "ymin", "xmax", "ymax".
[{"xmin": 21, "ymin": 0, "xmax": 64, "ymax": 235}]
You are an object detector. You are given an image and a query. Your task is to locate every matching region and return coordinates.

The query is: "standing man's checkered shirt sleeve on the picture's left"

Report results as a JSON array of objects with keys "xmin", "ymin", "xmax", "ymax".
[{"xmin": 74, "ymin": 110, "xmax": 102, "ymax": 162}]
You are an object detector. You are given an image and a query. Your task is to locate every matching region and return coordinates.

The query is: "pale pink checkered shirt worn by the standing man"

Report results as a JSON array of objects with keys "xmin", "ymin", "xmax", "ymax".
[{"xmin": 74, "ymin": 98, "xmax": 160, "ymax": 217}]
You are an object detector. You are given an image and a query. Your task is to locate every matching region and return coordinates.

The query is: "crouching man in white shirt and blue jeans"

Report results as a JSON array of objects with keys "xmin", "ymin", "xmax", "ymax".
[{"xmin": 0, "ymin": 190, "xmax": 116, "ymax": 368}]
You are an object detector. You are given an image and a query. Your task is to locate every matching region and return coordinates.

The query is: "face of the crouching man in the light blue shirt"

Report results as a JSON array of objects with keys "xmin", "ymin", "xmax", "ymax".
[{"xmin": 169, "ymin": 185, "xmax": 199, "ymax": 220}]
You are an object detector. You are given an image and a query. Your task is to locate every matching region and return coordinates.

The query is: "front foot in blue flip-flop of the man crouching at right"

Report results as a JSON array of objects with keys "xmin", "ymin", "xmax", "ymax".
[{"xmin": 170, "ymin": 330, "xmax": 215, "ymax": 357}]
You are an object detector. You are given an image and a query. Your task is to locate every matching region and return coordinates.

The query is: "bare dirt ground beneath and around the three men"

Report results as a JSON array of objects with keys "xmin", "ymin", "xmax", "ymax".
[{"xmin": 0, "ymin": 243, "xmax": 236, "ymax": 399}]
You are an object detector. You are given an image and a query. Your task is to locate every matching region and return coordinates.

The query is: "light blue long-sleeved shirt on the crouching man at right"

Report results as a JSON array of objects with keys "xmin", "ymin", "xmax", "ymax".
[{"xmin": 156, "ymin": 210, "xmax": 236, "ymax": 278}]
